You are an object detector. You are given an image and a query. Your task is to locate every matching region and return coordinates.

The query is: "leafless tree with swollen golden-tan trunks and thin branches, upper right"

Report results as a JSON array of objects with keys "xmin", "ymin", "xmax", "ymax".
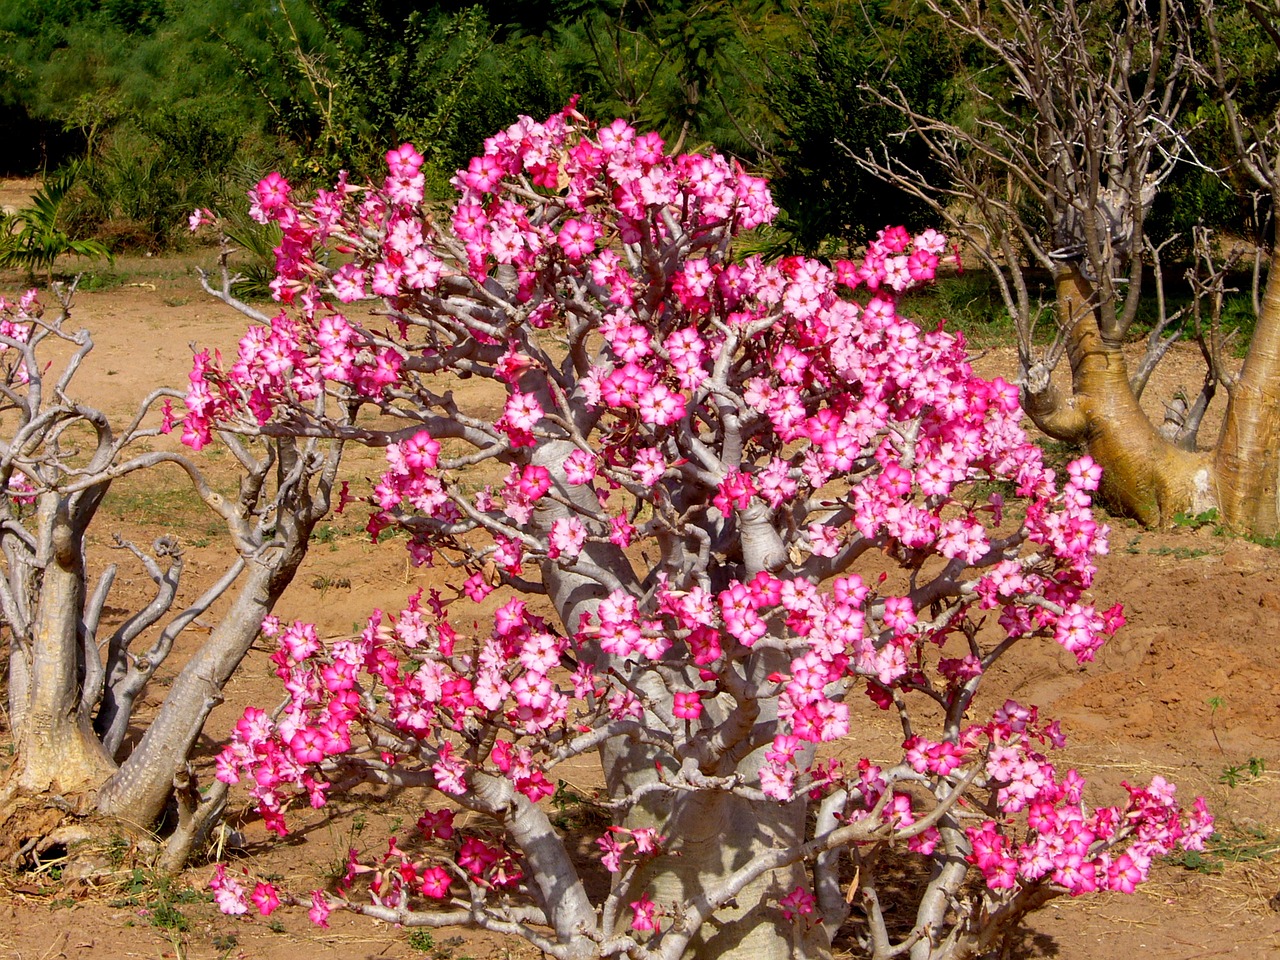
[{"xmin": 859, "ymin": 0, "xmax": 1280, "ymax": 535}]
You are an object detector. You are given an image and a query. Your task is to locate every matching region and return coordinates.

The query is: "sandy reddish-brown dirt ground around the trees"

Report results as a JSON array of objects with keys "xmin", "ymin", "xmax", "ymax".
[{"xmin": 0, "ymin": 239, "xmax": 1280, "ymax": 960}]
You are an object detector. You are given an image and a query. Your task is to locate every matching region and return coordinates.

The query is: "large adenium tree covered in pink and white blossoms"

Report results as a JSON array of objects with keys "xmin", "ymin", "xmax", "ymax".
[{"xmin": 197, "ymin": 109, "xmax": 1211, "ymax": 960}]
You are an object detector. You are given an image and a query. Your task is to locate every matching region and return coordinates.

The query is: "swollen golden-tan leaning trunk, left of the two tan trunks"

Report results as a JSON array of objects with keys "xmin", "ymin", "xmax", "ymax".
[{"xmin": 1025, "ymin": 269, "xmax": 1215, "ymax": 526}]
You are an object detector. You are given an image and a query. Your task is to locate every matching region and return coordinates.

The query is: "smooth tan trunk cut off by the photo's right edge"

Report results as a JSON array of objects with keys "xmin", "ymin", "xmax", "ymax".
[{"xmin": 1213, "ymin": 244, "xmax": 1280, "ymax": 536}]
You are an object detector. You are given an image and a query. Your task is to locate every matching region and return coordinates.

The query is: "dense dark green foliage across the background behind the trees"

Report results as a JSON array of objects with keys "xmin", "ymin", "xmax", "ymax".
[{"xmin": 0, "ymin": 0, "xmax": 1276, "ymax": 263}]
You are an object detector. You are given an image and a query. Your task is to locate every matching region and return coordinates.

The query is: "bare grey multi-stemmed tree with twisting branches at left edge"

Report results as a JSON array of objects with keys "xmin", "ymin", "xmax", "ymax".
[{"xmin": 0, "ymin": 292, "xmax": 340, "ymax": 868}]
